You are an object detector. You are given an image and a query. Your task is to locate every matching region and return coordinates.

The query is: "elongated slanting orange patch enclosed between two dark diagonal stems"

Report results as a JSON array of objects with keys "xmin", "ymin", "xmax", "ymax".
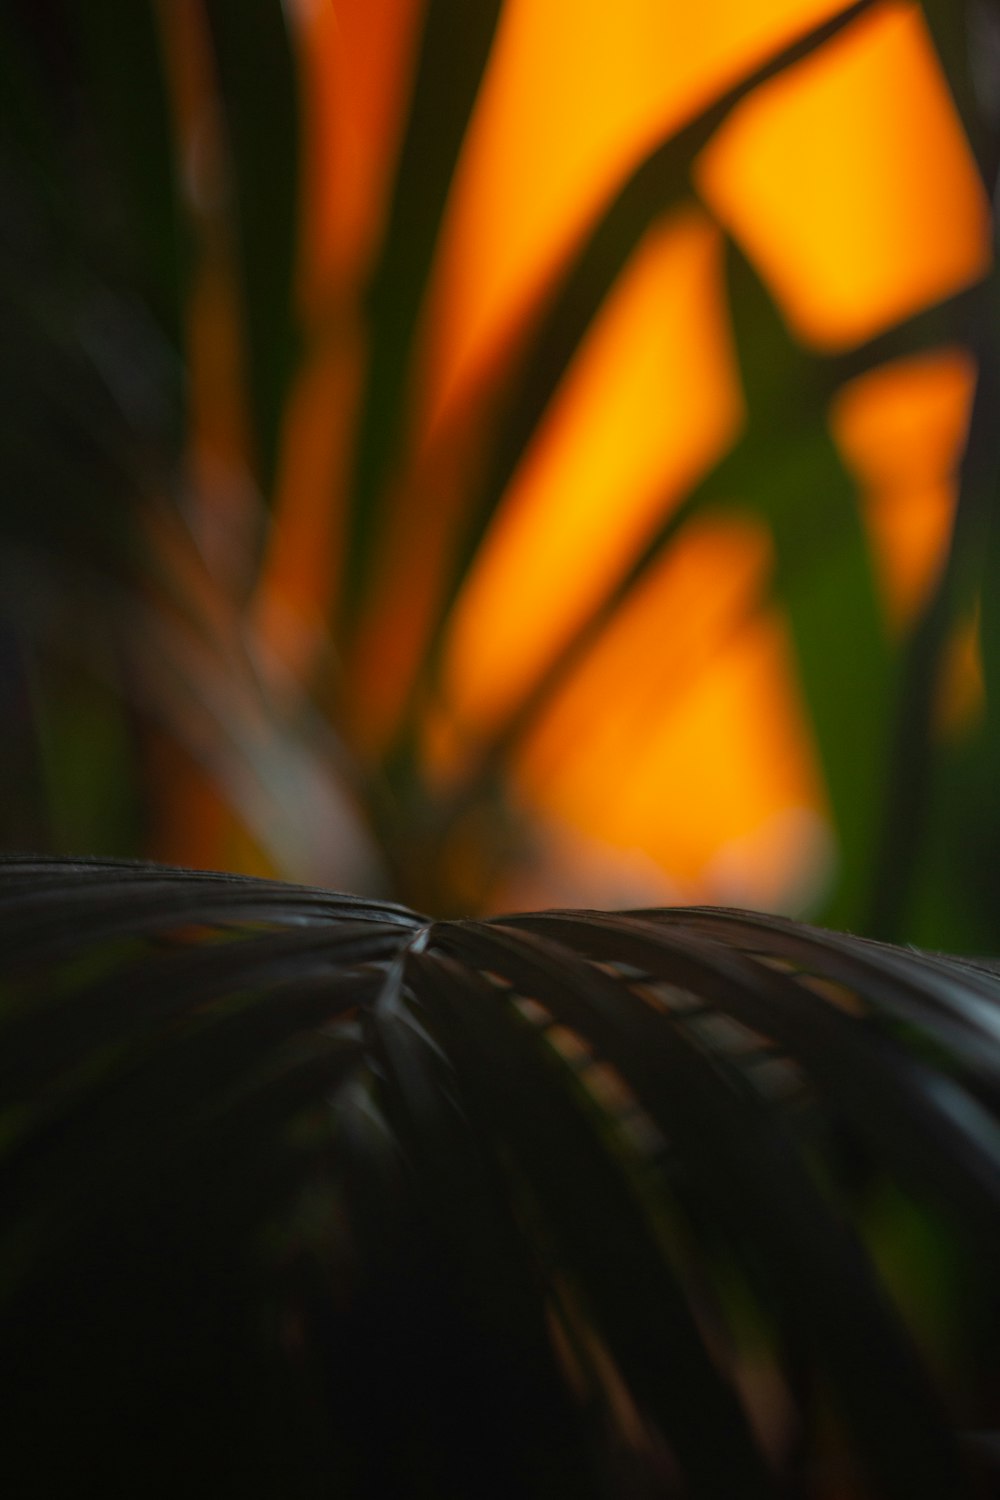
[{"xmin": 434, "ymin": 212, "xmax": 742, "ymax": 750}]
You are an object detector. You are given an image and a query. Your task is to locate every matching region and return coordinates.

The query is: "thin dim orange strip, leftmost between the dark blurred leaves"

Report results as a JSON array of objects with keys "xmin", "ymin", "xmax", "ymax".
[{"xmin": 145, "ymin": 0, "xmax": 262, "ymax": 873}]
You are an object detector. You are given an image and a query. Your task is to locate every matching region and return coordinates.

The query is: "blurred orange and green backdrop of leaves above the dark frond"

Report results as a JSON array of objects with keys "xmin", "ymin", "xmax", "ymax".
[{"xmin": 0, "ymin": 0, "xmax": 1000, "ymax": 950}]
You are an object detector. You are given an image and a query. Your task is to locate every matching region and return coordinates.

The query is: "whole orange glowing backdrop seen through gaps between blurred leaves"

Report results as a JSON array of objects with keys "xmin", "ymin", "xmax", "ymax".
[{"xmin": 152, "ymin": 0, "xmax": 990, "ymax": 909}]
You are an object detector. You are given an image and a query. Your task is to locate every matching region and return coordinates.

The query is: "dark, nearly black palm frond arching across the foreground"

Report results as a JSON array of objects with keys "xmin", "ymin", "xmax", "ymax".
[{"xmin": 0, "ymin": 858, "xmax": 1000, "ymax": 1500}]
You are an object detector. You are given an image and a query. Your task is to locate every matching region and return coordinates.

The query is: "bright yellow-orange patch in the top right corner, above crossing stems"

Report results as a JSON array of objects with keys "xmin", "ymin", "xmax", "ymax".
[{"xmin": 697, "ymin": 3, "xmax": 990, "ymax": 348}]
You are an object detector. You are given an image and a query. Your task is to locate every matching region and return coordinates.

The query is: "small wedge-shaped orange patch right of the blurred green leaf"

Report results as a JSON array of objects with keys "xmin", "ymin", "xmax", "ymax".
[{"xmin": 831, "ymin": 350, "xmax": 976, "ymax": 626}]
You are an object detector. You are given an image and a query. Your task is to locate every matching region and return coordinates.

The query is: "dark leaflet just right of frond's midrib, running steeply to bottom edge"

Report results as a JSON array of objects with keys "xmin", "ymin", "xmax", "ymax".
[{"xmin": 411, "ymin": 935, "xmax": 768, "ymax": 1497}]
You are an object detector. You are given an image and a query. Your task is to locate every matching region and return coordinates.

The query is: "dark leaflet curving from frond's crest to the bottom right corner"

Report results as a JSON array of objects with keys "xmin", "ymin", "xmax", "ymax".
[{"xmin": 437, "ymin": 917, "xmax": 961, "ymax": 1497}]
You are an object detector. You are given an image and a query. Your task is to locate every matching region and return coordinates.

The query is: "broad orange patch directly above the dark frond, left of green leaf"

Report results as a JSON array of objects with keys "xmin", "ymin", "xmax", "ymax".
[{"xmin": 516, "ymin": 518, "xmax": 823, "ymax": 905}]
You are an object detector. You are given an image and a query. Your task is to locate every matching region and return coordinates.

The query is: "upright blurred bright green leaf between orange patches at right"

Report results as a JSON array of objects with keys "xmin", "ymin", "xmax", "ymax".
[{"xmin": 712, "ymin": 245, "xmax": 895, "ymax": 926}]
